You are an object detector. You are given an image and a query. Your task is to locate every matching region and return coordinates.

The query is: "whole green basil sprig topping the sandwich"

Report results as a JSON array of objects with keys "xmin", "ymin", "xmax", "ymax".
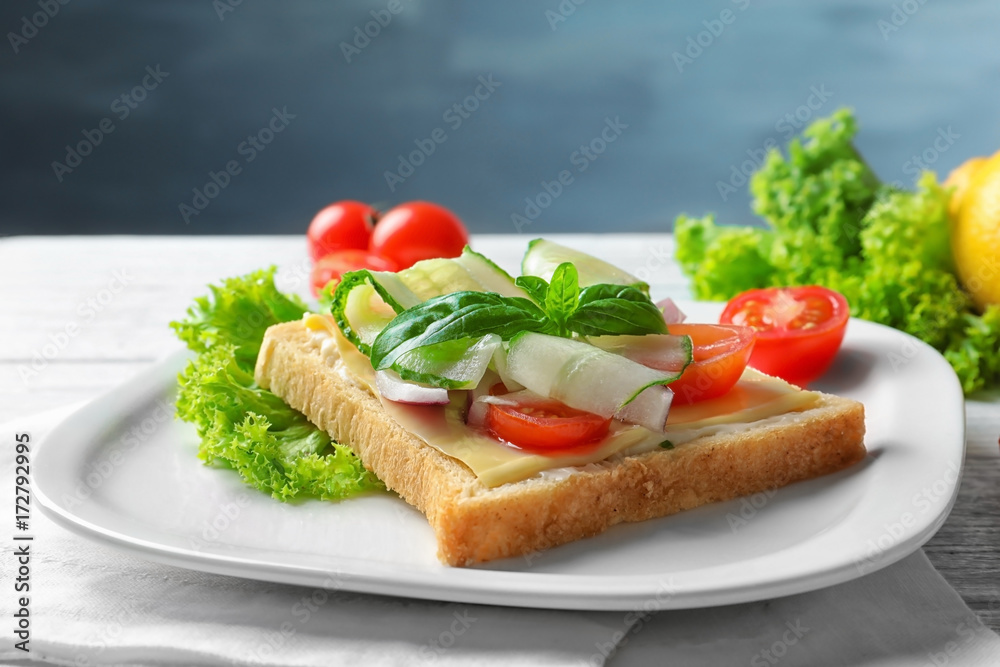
[{"xmin": 370, "ymin": 262, "xmax": 667, "ymax": 378}]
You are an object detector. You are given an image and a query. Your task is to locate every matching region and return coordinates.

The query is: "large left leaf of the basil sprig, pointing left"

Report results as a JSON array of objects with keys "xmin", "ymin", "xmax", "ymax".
[{"xmin": 371, "ymin": 292, "xmax": 552, "ymax": 370}]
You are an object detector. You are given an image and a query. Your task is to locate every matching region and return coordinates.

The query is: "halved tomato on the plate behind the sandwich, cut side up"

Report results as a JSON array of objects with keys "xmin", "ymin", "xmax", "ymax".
[{"xmin": 720, "ymin": 285, "xmax": 851, "ymax": 387}]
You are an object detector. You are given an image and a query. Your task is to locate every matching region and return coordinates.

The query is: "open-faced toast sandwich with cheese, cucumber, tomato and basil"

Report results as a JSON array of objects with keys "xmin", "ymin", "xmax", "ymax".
[{"xmin": 255, "ymin": 240, "xmax": 865, "ymax": 566}]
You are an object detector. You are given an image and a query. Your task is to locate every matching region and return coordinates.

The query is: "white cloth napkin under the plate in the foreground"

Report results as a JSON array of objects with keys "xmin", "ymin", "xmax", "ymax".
[{"xmin": 0, "ymin": 409, "xmax": 1000, "ymax": 667}]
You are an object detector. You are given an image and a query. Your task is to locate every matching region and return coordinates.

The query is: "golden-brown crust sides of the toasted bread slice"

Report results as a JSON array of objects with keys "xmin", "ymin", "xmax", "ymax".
[{"xmin": 256, "ymin": 322, "xmax": 865, "ymax": 566}]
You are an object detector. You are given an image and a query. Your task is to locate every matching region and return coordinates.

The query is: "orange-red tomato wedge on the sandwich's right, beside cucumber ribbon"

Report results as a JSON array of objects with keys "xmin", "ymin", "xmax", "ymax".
[{"xmin": 667, "ymin": 324, "xmax": 754, "ymax": 405}]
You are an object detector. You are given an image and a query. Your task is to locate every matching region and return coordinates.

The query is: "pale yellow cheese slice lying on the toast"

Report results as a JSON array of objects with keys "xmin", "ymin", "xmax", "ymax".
[{"xmin": 303, "ymin": 313, "xmax": 819, "ymax": 487}]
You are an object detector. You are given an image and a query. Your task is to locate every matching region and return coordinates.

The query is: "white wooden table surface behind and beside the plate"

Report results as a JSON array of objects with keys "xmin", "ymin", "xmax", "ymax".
[{"xmin": 0, "ymin": 234, "xmax": 1000, "ymax": 630}]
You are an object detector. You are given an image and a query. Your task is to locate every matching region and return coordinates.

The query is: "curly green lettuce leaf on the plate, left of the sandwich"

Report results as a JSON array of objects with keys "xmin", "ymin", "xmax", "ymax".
[{"xmin": 171, "ymin": 268, "xmax": 384, "ymax": 500}]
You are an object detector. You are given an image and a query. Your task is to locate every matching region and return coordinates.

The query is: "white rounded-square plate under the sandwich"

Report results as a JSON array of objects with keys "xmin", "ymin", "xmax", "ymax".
[{"xmin": 32, "ymin": 303, "xmax": 965, "ymax": 610}]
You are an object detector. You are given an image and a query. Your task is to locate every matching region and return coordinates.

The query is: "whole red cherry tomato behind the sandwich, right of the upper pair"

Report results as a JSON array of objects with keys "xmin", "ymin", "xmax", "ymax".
[{"xmin": 368, "ymin": 201, "xmax": 469, "ymax": 269}]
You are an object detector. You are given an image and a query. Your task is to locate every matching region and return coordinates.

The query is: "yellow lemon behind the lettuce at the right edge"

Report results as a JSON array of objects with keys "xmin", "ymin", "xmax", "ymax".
[{"xmin": 945, "ymin": 152, "xmax": 1000, "ymax": 309}]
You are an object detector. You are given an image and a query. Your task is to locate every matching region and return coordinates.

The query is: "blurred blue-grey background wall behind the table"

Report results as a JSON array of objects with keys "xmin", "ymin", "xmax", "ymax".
[{"xmin": 0, "ymin": 0, "xmax": 1000, "ymax": 235}]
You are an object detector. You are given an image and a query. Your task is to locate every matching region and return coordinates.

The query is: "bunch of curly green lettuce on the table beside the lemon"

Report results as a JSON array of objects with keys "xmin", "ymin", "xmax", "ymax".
[{"xmin": 674, "ymin": 109, "xmax": 1000, "ymax": 393}]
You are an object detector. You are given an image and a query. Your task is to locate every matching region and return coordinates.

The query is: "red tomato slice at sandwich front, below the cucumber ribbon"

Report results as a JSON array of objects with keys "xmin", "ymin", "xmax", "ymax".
[{"xmin": 486, "ymin": 399, "xmax": 611, "ymax": 454}]
